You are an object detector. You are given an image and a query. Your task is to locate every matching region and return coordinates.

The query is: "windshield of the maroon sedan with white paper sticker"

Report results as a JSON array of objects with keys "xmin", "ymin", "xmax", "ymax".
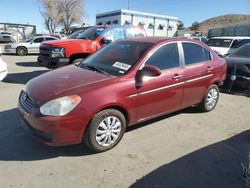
[{"xmin": 77, "ymin": 41, "xmax": 153, "ymax": 76}]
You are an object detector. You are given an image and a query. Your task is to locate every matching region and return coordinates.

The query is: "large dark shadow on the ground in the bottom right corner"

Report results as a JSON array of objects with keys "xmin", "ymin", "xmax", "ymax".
[{"xmin": 131, "ymin": 130, "xmax": 250, "ymax": 188}]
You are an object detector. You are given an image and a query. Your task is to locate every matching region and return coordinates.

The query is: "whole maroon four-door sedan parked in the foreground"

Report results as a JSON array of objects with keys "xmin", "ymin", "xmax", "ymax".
[{"xmin": 18, "ymin": 37, "xmax": 227, "ymax": 152}]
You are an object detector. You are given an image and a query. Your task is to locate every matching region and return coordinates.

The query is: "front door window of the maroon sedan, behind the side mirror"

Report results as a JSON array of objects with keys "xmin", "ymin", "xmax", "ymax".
[{"xmin": 146, "ymin": 43, "xmax": 179, "ymax": 70}]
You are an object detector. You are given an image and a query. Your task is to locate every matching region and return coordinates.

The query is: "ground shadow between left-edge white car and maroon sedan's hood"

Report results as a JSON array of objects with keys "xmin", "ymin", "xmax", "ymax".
[{"xmin": 2, "ymin": 70, "xmax": 49, "ymax": 84}]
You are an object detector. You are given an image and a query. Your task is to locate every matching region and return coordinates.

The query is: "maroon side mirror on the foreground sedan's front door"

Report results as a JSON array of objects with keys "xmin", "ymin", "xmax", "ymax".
[{"xmin": 136, "ymin": 65, "xmax": 161, "ymax": 88}]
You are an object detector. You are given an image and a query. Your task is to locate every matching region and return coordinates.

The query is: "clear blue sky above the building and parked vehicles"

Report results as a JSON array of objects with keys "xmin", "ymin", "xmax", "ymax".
[{"xmin": 0, "ymin": 0, "xmax": 250, "ymax": 32}]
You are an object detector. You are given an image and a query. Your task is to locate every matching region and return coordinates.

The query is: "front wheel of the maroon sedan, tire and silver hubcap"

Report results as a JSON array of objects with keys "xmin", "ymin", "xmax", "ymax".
[{"xmin": 84, "ymin": 109, "xmax": 126, "ymax": 152}]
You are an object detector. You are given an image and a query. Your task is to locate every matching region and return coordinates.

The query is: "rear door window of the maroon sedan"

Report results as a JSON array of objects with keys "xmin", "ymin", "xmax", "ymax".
[{"xmin": 182, "ymin": 42, "xmax": 211, "ymax": 65}]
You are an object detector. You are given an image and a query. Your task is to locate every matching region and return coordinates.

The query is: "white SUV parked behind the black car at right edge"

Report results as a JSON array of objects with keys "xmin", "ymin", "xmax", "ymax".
[{"xmin": 207, "ymin": 37, "xmax": 250, "ymax": 56}]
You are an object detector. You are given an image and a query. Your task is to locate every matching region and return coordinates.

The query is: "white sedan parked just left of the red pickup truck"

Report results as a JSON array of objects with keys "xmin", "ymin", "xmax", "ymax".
[{"xmin": 4, "ymin": 36, "xmax": 58, "ymax": 55}]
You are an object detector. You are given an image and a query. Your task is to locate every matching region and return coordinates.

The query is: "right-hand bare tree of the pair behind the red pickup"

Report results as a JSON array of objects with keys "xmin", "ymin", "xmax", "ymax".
[{"xmin": 57, "ymin": 0, "xmax": 85, "ymax": 33}]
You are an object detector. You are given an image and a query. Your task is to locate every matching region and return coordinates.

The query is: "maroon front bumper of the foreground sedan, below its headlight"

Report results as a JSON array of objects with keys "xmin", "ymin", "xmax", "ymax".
[{"xmin": 18, "ymin": 103, "xmax": 87, "ymax": 146}]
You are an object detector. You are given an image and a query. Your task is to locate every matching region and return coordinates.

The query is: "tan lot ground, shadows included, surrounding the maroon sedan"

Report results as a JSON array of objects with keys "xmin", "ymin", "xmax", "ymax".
[{"xmin": 0, "ymin": 46, "xmax": 250, "ymax": 188}]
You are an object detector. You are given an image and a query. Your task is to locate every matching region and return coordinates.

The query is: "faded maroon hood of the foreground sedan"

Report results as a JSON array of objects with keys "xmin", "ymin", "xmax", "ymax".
[{"xmin": 25, "ymin": 65, "xmax": 113, "ymax": 104}]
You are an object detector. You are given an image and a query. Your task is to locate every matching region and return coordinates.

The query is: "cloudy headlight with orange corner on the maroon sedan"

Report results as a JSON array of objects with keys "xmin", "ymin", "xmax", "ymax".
[{"xmin": 40, "ymin": 95, "xmax": 81, "ymax": 116}]
